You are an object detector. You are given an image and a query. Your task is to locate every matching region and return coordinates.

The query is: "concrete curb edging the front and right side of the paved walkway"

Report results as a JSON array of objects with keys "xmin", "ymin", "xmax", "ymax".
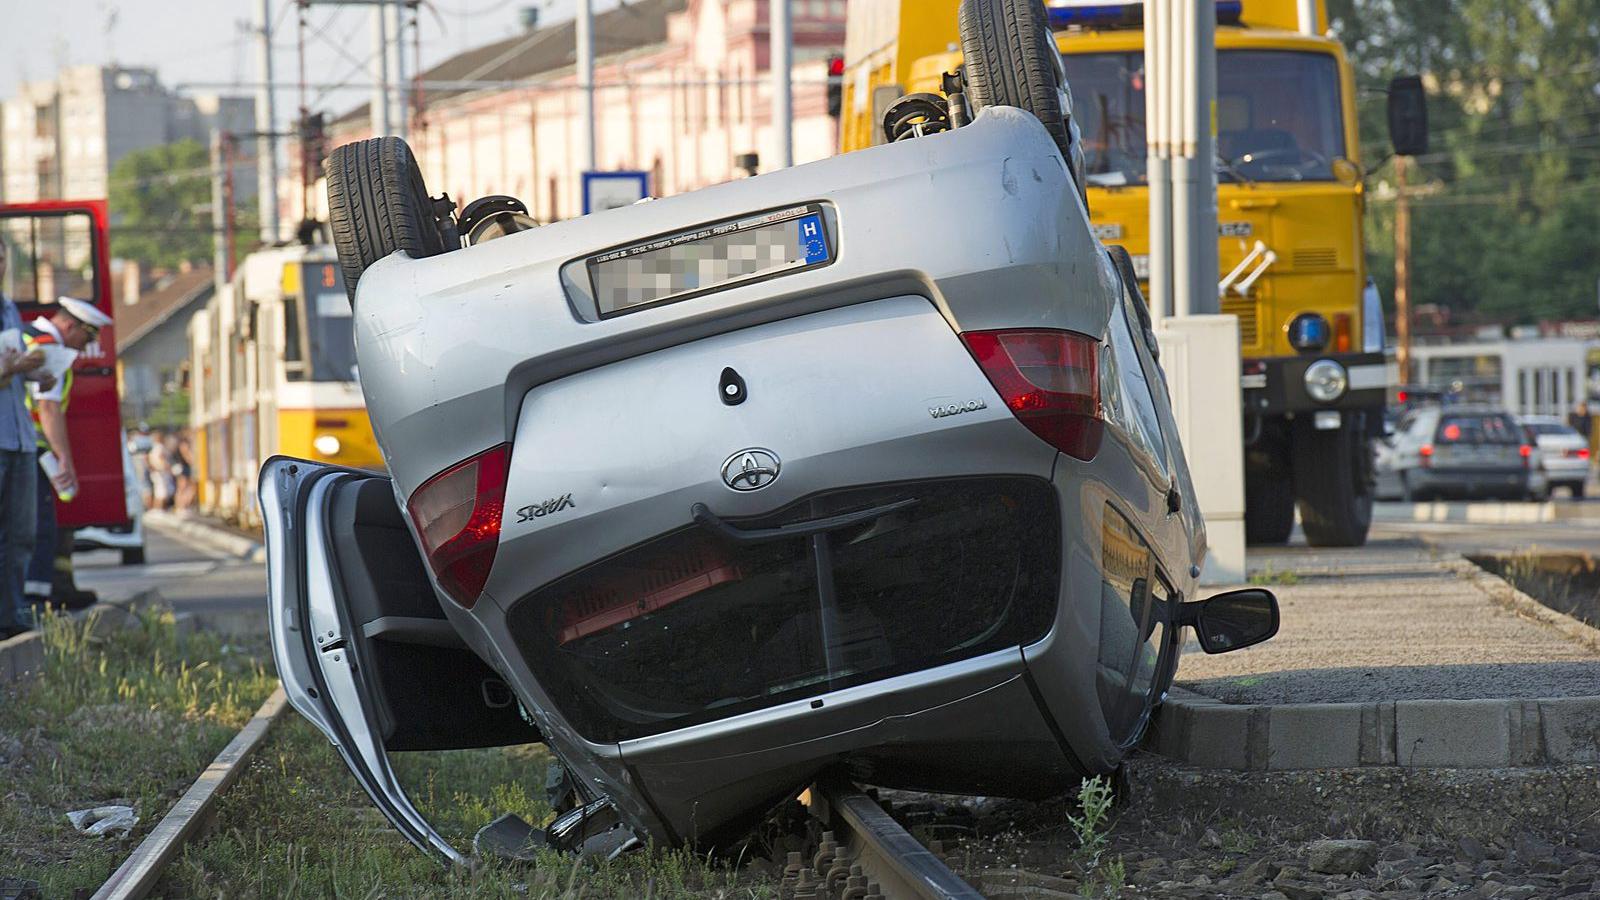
[{"xmin": 1146, "ymin": 557, "xmax": 1600, "ymax": 762}]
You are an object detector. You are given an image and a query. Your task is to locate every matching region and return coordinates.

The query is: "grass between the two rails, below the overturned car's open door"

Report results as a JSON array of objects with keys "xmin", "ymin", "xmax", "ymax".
[{"xmin": 164, "ymin": 704, "xmax": 776, "ymax": 900}]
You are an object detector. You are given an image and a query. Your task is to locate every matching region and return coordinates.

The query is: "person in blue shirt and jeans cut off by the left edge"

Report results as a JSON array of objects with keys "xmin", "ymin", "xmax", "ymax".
[{"xmin": 0, "ymin": 237, "xmax": 45, "ymax": 641}]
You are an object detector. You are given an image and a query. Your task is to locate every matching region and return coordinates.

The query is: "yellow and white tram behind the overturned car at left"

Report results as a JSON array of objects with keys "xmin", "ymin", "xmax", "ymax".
[{"xmin": 189, "ymin": 245, "xmax": 382, "ymax": 525}]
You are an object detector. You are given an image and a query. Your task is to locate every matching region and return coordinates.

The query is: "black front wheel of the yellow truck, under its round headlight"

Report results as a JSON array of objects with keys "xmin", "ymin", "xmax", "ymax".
[{"xmin": 1291, "ymin": 413, "xmax": 1373, "ymax": 546}]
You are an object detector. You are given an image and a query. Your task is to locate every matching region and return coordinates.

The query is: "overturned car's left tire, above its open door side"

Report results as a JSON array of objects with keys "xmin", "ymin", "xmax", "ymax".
[{"xmin": 326, "ymin": 138, "xmax": 450, "ymax": 303}]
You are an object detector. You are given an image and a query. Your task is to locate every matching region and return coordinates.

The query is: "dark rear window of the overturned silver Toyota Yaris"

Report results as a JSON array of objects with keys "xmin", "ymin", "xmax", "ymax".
[{"xmin": 507, "ymin": 477, "xmax": 1061, "ymax": 741}]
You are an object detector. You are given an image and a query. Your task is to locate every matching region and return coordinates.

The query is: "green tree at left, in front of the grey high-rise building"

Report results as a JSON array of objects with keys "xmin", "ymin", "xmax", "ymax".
[{"xmin": 109, "ymin": 139, "xmax": 256, "ymax": 269}]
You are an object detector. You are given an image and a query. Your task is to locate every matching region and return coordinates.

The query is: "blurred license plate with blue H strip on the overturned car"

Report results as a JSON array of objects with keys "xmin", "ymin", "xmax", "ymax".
[{"xmin": 587, "ymin": 203, "xmax": 837, "ymax": 319}]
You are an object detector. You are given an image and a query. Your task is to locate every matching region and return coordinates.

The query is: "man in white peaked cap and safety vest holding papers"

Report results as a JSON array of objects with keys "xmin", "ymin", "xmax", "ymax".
[{"xmin": 22, "ymin": 296, "xmax": 110, "ymax": 609}]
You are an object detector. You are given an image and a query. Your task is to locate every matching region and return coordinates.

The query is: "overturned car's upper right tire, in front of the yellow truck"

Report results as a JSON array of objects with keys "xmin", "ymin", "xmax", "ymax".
[{"xmin": 958, "ymin": 0, "xmax": 1086, "ymax": 196}]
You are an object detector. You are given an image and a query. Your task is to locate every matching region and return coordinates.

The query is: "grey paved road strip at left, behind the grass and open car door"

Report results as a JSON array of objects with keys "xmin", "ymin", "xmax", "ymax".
[{"xmin": 74, "ymin": 515, "xmax": 267, "ymax": 612}]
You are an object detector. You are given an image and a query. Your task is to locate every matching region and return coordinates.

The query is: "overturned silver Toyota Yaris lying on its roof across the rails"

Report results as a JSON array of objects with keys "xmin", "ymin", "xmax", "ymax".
[{"xmin": 259, "ymin": 0, "xmax": 1278, "ymax": 858}]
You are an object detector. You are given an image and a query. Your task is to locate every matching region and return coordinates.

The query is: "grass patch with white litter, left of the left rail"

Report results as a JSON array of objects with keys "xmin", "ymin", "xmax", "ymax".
[{"xmin": 0, "ymin": 610, "xmax": 277, "ymax": 897}]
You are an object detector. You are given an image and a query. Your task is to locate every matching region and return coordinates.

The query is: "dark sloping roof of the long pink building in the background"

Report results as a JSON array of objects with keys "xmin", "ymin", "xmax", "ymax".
[{"xmin": 336, "ymin": 0, "xmax": 688, "ymax": 125}]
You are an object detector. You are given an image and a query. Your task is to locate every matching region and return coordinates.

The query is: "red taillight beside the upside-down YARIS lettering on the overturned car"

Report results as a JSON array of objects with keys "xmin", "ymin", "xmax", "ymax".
[{"xmin": 406, "ymin": 444, "xmax": 510, "ymax": 609}]
